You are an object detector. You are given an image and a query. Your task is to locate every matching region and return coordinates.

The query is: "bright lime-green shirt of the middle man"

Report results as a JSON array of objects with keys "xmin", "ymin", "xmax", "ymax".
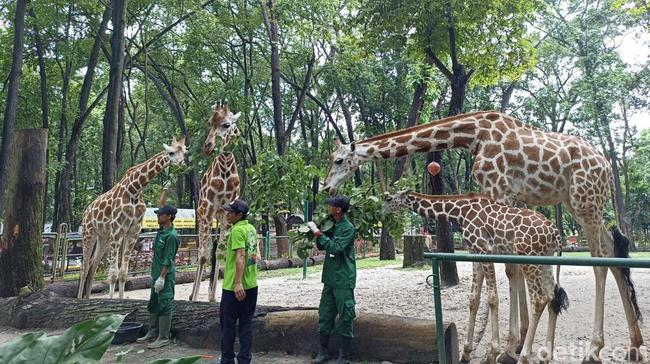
[{"xmin": 223, "ymin": 219, "xmax": 257, "ymax": 291}]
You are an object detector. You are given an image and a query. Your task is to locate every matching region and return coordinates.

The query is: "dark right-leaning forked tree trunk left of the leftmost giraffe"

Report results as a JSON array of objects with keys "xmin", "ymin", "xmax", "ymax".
[{"xmin": 52, "ymin": 4, "xmax": 111, "ymax": 230}]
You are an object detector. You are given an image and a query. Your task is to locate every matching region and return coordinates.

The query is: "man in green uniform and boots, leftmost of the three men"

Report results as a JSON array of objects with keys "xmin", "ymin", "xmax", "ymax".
[{"xmin": 137, "ymin": 205, "xmax": 180, "ymax": 349}]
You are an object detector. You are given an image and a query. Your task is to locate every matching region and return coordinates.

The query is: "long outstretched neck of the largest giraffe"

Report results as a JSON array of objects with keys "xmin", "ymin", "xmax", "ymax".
[{"xmin": 356, "ymin": 111, "xmax": 501, "ymax": 161}]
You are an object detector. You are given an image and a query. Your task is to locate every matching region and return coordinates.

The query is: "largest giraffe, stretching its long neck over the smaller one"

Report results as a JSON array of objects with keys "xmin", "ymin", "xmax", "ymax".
[{"xmin": 324, "ymin": 111, "xmax": 643, "ymax": 363}]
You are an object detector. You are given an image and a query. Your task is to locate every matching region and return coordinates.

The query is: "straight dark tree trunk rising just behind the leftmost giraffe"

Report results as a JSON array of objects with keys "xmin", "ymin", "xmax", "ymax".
[{"xmin": 102, "ymin": 0, "xmax": 127, "ymax": 192}]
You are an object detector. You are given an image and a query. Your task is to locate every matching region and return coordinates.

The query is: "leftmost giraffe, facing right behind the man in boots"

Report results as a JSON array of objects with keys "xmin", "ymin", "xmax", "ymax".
[{"xmin": 77, "ymin": 137, "xmax": 187, "ymax": 299}]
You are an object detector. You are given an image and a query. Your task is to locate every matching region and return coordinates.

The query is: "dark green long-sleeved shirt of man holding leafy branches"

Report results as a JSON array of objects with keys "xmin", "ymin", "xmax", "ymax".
[{"xmin": 316, "ymin": 215, "xmax": 357, "ymax": 288}]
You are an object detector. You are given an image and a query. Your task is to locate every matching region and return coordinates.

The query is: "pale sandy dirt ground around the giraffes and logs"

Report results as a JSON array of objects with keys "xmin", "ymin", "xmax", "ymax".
[{"xmin": 0, "ymin": 263, "xmax": 650, "ymax": 364}]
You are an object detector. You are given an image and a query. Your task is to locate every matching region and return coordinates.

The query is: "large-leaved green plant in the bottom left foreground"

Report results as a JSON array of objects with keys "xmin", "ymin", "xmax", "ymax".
[{"xmin": 0, "ymin": 314, "xmax": 200, "ymax": 364}]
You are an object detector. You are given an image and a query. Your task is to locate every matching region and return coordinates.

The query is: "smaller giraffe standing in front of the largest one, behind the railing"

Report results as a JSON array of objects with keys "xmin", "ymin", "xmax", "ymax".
[{"xmin": 383, "ymin": 191, "xmax": 568, "ymax": 363}]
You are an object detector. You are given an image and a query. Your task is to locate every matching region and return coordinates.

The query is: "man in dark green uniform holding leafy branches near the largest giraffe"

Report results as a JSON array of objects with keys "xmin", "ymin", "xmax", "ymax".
[{"xmin": 307, "ymin": 195, "xmax": 357, "ymax": 364}]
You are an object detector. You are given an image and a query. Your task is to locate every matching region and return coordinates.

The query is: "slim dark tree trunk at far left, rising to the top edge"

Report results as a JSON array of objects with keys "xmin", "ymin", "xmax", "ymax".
[{"xmin": 0, "ymin": 0, "xmax": 27, "ymax": 214}]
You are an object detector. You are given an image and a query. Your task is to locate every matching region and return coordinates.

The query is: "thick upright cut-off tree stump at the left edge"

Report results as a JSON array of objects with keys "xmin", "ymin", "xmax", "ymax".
[{"xmin": 0, "ymin": 129, "xmax": 47, "ymax": 297}]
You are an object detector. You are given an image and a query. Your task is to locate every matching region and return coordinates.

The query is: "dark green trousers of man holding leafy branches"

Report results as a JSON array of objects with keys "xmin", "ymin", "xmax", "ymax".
[{"xmin": 318, "ymin": 284, "xmax": 356, "ymax": 337}]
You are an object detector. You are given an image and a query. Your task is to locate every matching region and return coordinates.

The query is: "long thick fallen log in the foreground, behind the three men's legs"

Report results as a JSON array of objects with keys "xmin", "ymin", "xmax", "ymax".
[{"xmin": 0, "ymin": 291, "xmax": 458, "ymax": 363}]
